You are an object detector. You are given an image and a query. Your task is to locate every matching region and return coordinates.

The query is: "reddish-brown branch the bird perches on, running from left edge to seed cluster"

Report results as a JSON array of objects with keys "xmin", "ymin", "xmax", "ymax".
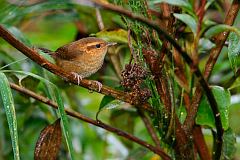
[{"xmin": 0, "ymin": 24, "xmax": 152, "ymax": 112}]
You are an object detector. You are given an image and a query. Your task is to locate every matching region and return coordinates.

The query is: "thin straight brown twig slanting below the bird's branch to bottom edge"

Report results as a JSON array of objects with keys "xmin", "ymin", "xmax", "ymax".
[{"xmin": 10, "ymin": 83, "xmax": 171, "ymax": 160}]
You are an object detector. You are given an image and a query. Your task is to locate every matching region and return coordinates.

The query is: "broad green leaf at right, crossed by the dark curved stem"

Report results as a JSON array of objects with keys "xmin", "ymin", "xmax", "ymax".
[{"xmin": 196, "ymin": 86, "xmax": 231, "ymax": 130}]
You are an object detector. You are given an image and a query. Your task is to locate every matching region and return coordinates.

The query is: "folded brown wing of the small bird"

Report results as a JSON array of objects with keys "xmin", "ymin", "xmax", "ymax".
[{"xmin": 55, "ymin": 43, "xmax": 83, "ymax": 60}]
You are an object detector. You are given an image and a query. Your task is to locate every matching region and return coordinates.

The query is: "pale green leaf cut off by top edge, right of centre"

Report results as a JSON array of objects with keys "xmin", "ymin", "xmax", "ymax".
[{"xmin": 151, "ymin": 0, "xmax": 195, "ymax": 15}]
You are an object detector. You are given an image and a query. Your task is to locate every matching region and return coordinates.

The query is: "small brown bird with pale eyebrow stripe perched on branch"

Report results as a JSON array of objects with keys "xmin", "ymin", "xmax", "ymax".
[{"xmin": 41, "ymin": 37, "xmax": 116, "ymax": 91}]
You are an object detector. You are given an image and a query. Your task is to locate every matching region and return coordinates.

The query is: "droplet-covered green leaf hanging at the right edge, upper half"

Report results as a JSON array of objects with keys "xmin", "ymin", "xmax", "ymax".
[{"xmin": 228, "ymin": 32, "xmax": 240, "ymax": 72}]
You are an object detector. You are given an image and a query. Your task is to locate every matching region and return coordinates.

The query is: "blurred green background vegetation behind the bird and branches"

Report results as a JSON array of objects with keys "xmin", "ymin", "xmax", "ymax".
[{"xmin": 0, "ymin": 0, "xmax": 240, "ymax": 160}]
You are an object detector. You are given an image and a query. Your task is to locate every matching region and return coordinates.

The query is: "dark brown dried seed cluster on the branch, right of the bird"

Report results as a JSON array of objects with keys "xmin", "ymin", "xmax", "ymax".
[{"xmin": 121, "ymin": 63, "xmax": 151, "ymax": 104}]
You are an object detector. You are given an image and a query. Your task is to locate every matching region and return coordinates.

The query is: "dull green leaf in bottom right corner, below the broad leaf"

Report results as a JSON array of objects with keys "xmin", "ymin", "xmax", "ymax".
[{"xmin": 222, "ymin": 128, "xmax": 237, "ymax": 160}]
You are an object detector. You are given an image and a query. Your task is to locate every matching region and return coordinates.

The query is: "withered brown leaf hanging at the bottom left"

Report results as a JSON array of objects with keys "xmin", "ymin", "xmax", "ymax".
[{"xmin": 34, "ymin": 119, "xmax": 62, "ymax": 160}]
